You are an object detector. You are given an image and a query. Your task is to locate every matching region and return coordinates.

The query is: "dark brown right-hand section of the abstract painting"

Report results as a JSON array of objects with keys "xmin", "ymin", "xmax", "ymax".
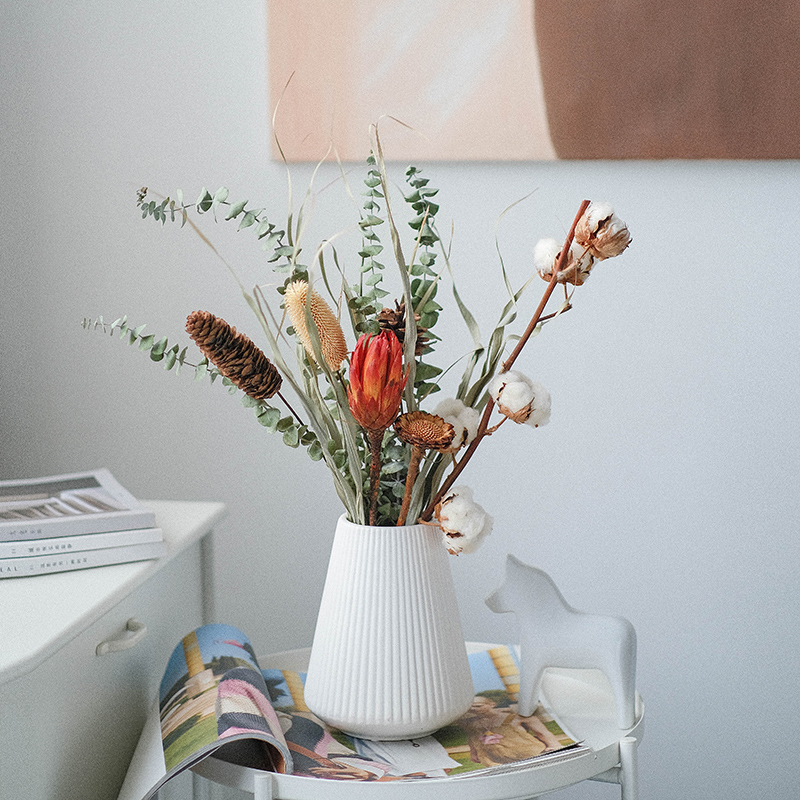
[{"xmin": 535, "ymin": 0, "xmax": 800, "ymax": 159}]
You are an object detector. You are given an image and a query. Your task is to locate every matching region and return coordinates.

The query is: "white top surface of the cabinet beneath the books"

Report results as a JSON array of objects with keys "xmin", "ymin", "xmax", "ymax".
[{"xmin": 0, "ymin": 500, "xmax": 225, "ymax": 685}]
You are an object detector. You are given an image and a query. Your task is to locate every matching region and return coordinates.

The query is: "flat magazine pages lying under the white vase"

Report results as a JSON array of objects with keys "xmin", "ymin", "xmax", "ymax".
[{"xmin": 262, "ymin": 646, "xmax": 579, "ymax": 781}]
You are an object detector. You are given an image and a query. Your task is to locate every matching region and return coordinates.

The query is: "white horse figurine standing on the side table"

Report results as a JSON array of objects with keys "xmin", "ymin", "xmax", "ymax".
[{"xmin": 486, "ymin": 555, "xmax": 636, "ymax": 729}]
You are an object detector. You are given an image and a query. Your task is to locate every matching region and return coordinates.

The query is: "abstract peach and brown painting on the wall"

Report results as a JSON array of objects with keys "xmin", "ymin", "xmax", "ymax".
[{"xmin": 267, "ymin": 0, "xmax": 800, "ymax": 161}]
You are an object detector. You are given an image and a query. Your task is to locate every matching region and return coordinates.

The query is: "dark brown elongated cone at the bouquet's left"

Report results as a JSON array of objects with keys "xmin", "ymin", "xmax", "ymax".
[{"xmin": 186, "ymin": 311, "xmax": 281, "ymax": 400}]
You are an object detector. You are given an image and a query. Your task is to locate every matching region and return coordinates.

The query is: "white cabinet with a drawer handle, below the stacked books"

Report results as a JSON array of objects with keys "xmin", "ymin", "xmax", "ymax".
[{"xmin": 0, "ymin": 501, "xmax": 224, "ymax": 800}]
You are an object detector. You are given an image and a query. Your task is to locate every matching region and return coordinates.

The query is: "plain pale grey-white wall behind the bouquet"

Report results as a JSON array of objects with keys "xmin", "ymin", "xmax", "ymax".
[{"xmin": 0, "ymin": 0, "xmax": 800, "ymax": 800}]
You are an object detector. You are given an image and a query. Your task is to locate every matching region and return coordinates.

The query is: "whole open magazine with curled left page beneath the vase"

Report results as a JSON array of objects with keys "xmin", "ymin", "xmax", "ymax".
[{"xmin": 119, "ymin": 624, "xmax": 580, "ymax": 800}]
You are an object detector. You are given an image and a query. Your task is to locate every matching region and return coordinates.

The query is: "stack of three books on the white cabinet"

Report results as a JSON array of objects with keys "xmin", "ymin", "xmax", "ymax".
[{"xmin": 0, "ymin": 469, "xmax": 166, "ymax": 578}]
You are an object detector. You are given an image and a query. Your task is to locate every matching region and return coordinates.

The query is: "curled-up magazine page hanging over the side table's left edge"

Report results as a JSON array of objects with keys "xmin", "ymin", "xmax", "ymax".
[{"xmin": 119, "ymin": 624, "xmax": 293, "ymax": 800}]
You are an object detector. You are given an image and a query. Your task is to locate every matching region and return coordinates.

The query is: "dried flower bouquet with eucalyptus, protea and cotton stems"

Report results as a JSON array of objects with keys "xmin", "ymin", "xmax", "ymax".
[{"xmin": 84, "ymin": 129, "xmax": 630, "ymax": 554}]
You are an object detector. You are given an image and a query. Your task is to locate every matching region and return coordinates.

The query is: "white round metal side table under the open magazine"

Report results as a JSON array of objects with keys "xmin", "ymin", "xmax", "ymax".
[{"xmin": 192, "ymin": 643, "xmax": 644, "ymax": 800}]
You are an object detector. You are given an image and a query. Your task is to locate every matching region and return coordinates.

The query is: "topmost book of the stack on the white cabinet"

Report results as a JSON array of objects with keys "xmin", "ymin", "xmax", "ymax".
[{"xmin": 0, "ymin": 469, "xmax": 155, "ymax": 542}]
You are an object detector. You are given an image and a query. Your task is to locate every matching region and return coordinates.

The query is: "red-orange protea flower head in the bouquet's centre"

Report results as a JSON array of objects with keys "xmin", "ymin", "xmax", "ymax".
[{"xmin": 347, "ymin": 331, "xmax": 408, "ymax": 433}]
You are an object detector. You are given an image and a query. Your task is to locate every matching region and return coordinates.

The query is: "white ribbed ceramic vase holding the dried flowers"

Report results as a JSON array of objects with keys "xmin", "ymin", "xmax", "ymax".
[{"xmin": 305, "ymin": 515, "xmax": 474, "ymax": 739}]
